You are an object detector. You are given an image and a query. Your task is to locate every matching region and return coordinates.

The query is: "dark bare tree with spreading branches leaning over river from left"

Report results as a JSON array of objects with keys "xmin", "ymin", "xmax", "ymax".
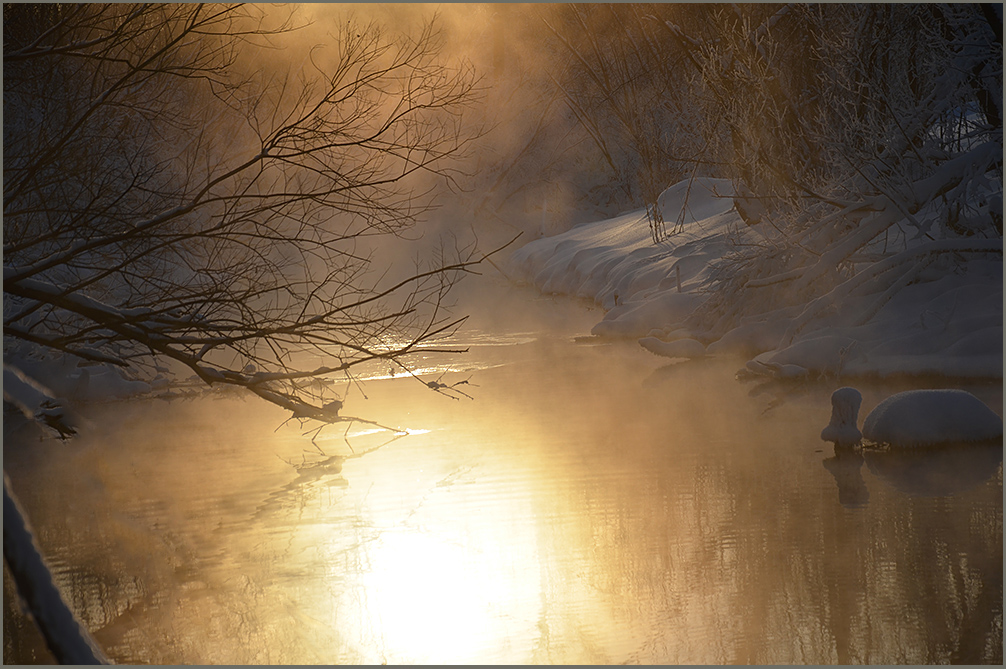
[{"xmin": 3, "ymin": 4, "xmax": 480, "ymax": 428}]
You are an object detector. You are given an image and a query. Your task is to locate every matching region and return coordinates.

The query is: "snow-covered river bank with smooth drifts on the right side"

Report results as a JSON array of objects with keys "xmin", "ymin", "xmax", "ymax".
[{"xmin": 509, "ymin": 178, "xmax": 1003, "ymax": 378}]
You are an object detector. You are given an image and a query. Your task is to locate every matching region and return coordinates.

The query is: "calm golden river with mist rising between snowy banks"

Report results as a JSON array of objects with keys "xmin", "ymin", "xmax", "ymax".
[{"xmin": 4, "ymin": 279, "xmax": 1003, "ymax": 664}]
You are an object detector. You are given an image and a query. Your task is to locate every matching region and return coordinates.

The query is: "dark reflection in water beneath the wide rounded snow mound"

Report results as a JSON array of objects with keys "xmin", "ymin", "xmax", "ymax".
[{"xmin": 863, "ymin": 444, "xmax": 1003, "ymax": 497}]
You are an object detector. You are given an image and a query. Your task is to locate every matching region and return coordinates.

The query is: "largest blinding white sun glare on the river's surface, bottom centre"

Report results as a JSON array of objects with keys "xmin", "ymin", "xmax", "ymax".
[{"xmin": 283, "ymin": 431, "xmax": 542, "ymax": 664}]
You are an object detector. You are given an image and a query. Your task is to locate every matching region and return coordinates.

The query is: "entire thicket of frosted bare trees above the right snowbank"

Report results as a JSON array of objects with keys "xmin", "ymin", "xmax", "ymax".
[{"xmin": 507, "ymin": 3, "xmax": 1003, "ymax": 374}]
